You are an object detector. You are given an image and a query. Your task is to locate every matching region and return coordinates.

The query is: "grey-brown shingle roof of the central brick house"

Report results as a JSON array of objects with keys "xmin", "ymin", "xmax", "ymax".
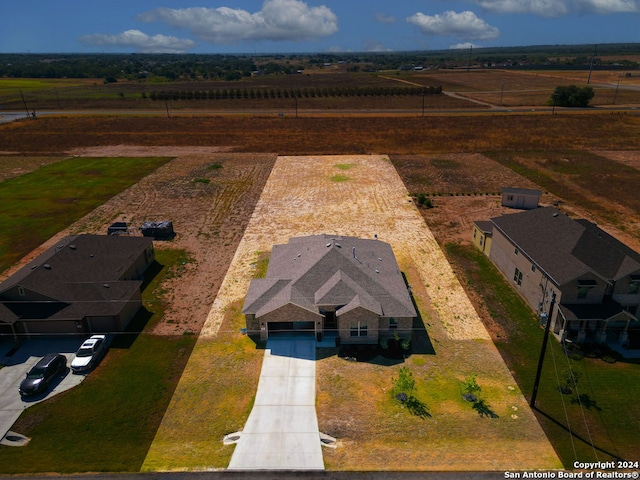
[{"xmin": 243, "ymin": 235, "xmax": 416, "ymax": 317}]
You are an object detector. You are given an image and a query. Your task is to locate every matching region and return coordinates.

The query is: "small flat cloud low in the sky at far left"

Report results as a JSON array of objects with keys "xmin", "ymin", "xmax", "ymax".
[{"xmin": 79, "ymin": 30, "xmax": 195, "ymax": 53}]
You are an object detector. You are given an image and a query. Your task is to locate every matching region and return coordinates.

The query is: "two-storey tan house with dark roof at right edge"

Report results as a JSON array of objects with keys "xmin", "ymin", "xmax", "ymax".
[{"xmin": 474, "ymin": 207, "xmax": 640, "ymax": 349}]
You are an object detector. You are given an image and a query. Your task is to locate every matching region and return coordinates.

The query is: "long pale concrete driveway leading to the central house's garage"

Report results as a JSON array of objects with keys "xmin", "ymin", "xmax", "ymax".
[{"xmin": 229, "ymin": 336, "xmax": 324, "ymax": 470}]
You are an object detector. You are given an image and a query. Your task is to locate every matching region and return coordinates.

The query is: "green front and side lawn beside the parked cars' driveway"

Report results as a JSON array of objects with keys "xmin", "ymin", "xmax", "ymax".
[{"xmin": 0, "ymin": 250, "xmax": 195, "ymax": 474}]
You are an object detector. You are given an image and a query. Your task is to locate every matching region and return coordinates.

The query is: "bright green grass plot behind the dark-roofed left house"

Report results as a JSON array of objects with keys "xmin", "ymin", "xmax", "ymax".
[{"xmin": 0, "ymin": 157, "xmax": 170, "ymax": 272}]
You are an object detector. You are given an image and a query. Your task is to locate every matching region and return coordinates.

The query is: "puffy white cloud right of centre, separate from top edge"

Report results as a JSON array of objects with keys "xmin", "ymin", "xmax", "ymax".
[{"xmin": 407, "ymin": 10, "xmax": 500, "ymax": 40}]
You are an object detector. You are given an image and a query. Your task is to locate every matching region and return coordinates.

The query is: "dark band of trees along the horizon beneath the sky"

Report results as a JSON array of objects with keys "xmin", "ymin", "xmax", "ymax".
[{"xmin": 0, "ymin": 43, "xmax": 640, "ymax": 81}]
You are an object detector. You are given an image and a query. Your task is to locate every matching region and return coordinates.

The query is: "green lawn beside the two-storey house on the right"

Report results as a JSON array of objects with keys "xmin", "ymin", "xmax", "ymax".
[{"xmin": 446, "ymin": 244, "xmax": 640, "ymax": 468}]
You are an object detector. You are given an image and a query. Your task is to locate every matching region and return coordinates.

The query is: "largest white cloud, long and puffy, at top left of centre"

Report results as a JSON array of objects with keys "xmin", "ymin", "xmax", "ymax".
[{"xmin": 137, "ymin": 0, "xmax": 338, "ymax": 45}]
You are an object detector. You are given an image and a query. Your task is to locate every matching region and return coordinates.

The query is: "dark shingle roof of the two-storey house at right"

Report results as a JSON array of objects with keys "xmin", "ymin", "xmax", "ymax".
[{"xmin": 491, "ymin": 207, "xmax": 640, "ymax": 285}]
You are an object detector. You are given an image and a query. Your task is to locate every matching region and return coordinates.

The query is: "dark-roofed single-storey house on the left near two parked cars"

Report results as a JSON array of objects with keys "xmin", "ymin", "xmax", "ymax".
[{"xmin": 0, "ymin": 235, "xmax": 155, "ymax": 336}]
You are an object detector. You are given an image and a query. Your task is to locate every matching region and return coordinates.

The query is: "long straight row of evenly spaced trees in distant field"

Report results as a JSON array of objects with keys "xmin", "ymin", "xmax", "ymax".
[{"xmin": 147, "ymin": 86, "xmax": 442, "ymax": 100}]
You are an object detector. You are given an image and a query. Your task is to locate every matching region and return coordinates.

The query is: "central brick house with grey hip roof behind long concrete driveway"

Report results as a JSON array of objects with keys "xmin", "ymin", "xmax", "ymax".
[{"xmin": 242, "ymin": 235, "xmax": 417, "ymax": 344}]
